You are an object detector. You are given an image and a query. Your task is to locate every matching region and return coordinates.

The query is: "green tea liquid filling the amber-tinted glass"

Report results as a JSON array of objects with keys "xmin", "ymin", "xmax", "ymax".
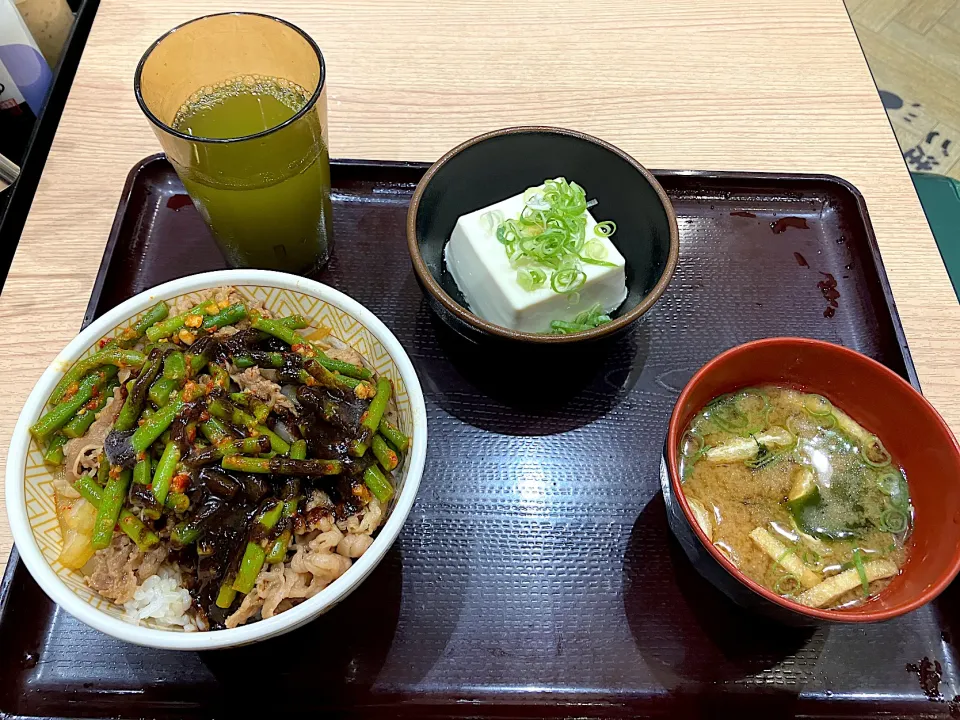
[{"xmin": 173, "ymin": 76, "xmax": 332, "ymax": 272}]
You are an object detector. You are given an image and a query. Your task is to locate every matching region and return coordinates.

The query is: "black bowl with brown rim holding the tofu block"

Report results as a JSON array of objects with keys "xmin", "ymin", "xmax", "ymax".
[{"xmin": 407, "ymin": 127, "xmax": 680, "ymax": 345}]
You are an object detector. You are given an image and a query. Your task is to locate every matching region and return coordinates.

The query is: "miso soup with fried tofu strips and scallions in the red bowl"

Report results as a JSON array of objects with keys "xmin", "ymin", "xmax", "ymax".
[{"xmin": 679, "ymin": 386, "xmax": 913, "ymax": 608}]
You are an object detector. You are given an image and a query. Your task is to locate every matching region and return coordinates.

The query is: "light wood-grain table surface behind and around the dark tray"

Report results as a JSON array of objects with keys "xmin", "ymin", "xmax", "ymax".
[{"xmin": 0, "ymin": 0, "xmax": 960, "ymax": 568}]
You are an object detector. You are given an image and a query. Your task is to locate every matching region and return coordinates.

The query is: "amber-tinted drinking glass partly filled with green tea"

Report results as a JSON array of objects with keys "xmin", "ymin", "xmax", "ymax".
[{"xmin": 134, "ymin": 13, "xmax": 333, "ymax": 274}]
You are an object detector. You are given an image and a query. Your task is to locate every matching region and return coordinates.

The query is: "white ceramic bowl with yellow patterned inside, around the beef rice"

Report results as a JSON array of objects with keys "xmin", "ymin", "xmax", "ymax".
[{"xmin": 6, "ymin": 270, "xmax": 427, "ymax": 650}]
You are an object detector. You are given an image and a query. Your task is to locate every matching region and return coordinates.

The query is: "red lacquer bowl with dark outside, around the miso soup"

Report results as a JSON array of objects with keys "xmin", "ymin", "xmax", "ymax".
[{"xmin": 663, "ymin": 338, "xmax": 960, "ymax": 623}]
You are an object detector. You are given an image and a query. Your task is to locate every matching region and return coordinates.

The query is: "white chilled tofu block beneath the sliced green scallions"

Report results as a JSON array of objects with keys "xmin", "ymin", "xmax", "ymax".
[{"xmin": 444, "ymin": 187, "xmax": 627, "ymax": 333}]
